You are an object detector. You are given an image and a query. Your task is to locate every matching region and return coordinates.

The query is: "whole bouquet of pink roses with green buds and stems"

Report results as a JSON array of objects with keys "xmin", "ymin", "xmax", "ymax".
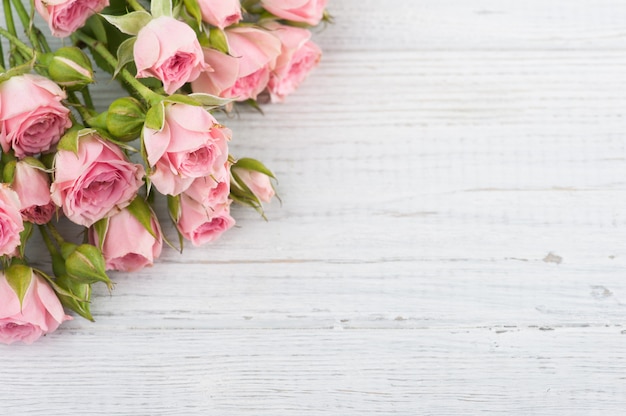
[{"xmin": 0, "ymin": 0, "xmax": 329, "ymax": 343}]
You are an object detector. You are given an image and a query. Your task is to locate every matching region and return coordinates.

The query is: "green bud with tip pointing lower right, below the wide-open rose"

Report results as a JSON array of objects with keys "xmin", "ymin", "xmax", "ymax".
[{"xmin": 61, "ymin": 243, "xmax": 113, "ymax": 289}]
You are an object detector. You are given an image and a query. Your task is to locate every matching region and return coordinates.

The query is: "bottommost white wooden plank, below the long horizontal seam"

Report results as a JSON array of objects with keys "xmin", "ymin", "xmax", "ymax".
[{"xmin": 0, "ymin": 328, "xmax": 626, "ymax": 416}]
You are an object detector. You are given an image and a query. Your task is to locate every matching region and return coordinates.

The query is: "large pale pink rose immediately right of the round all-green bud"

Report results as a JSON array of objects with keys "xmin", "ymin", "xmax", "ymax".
[{"xmin": 143, "ymin": 104, "xmax": 231, "ymax": 195}]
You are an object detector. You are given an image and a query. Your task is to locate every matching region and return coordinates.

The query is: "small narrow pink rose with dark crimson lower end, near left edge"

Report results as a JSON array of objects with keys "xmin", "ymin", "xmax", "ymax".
[{"xmin": 11, "ymin": 161, "xmax": 56, "ymax": 224}]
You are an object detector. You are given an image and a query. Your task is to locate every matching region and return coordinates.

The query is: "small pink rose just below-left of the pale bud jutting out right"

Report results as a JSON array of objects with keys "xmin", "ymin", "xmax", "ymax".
[{"xmin": 176, "ymin": 194, "xmax": 235, "ymax": 246}]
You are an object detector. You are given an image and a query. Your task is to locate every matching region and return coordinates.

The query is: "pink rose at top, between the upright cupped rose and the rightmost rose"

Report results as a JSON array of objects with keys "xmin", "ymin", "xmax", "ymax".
[{"xmin": 191, "ymin": 26, "xmax": 280, "ymax": 101}]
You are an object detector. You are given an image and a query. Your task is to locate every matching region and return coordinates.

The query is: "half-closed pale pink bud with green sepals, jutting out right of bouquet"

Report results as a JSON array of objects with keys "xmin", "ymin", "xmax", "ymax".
[{"xmin": 230, "ymin": 158, "xmax": 276, "ymax": 204}]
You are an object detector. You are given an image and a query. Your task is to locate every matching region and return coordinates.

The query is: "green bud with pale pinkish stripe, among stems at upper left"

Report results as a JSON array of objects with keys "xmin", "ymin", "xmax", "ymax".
[{"xmin": 48, "ymin": 46, "xmax": 94, "ymax": 90}]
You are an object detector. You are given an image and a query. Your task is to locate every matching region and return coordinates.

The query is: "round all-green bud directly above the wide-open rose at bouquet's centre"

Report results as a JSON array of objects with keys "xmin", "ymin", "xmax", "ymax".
[{"xmin": 106, "ymin": 97, "xmax": 146, "ymax": 142}]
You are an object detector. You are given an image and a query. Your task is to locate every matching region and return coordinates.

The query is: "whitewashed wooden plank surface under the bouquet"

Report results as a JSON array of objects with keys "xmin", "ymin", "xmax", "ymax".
[{"xmin": 0, "ymin": 0, "xmax": 626, "ymax": 416}]
